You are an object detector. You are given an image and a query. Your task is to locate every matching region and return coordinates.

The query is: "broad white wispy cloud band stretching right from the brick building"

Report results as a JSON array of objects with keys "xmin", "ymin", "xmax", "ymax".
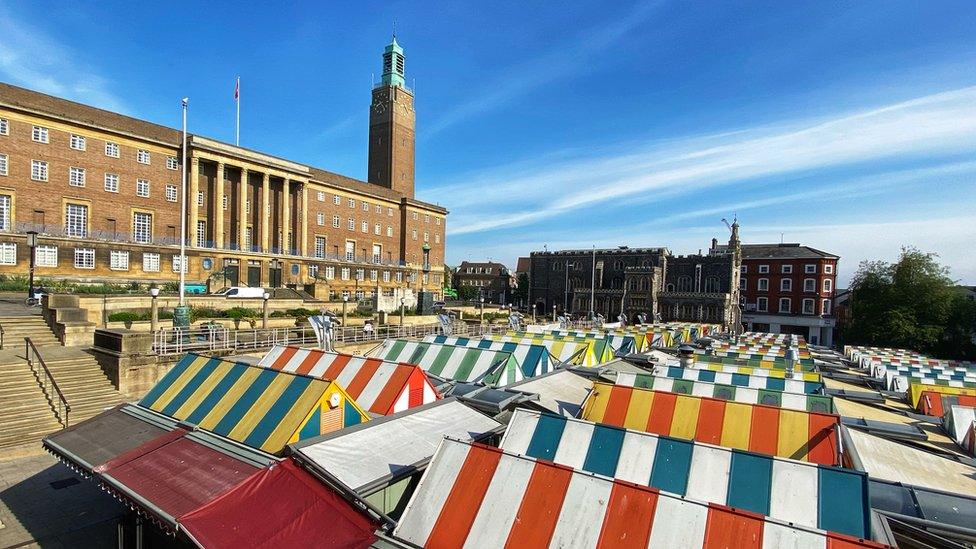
[{"xmin": 442, "ymin": 86, "xmax": 976, "ymax": 235}]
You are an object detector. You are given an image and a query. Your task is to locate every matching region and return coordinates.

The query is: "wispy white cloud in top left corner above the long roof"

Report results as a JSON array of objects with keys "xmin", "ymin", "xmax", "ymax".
[{"xmin": 0, "ymin": 6, "xmax": 128, "ymax": 112}]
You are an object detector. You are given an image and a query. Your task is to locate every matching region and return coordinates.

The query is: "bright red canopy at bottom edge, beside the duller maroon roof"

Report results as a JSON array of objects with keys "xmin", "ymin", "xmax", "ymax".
[{"xmin": 179, "ymin": 459, "xmax": 376, "ymax": 548}]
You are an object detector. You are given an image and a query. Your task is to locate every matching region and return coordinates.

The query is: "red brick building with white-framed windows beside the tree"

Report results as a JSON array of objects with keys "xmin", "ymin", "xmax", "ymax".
[{"xmin": 713, "ymin": 243, "xmax": 840, "ymax": 346}]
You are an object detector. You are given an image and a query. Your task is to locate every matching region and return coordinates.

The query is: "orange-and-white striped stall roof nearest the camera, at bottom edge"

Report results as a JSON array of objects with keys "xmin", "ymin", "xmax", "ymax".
[{"xmin": 393, "ymin": 439, "xmax": 881, "ymax": 549}]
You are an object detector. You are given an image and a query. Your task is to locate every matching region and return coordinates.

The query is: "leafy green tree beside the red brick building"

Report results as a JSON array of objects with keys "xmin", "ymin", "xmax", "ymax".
[{"xmin": 844, "ymin": 247, "xmax": 976, "ymax": 359}]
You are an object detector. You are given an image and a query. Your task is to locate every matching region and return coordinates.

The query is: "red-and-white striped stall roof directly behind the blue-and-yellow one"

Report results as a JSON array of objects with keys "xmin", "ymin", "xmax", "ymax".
[{"xmin": 258, "ymin": 345, "xmax": 440, "ymax": 416}]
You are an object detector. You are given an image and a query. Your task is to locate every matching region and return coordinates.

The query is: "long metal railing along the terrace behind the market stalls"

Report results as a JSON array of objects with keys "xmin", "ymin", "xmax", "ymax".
[{"xmin": 153, "ymin": 316, "xmax": 508, "ymax": 355}]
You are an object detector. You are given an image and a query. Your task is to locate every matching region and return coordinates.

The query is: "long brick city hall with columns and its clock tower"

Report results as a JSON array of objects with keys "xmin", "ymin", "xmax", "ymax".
[{"xmin": 0, "ymin": 39, "xmax": 448, "ymax": 297}]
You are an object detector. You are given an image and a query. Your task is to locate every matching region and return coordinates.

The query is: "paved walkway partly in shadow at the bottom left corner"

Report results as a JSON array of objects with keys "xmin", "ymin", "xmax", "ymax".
[{"xmin": 0, "ymin": 454, "xmax": 122, "ymax": 549}]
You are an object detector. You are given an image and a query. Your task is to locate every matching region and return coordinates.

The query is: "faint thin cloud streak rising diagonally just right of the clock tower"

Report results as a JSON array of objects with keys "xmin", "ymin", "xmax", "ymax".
[{"xmin": 421, "ymin": 2, "xmax": 659, "ymax": 139}]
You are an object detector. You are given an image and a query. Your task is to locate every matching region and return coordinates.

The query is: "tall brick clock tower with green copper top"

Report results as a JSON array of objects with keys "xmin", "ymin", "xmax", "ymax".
[{"xmin": 366, "ymin": 35, "xmax": 416, "ymax": 198}]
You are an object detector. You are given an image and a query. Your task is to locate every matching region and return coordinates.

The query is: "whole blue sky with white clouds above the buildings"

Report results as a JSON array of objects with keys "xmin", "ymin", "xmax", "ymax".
[{"xmin": 0, "ymin": 0, "xmax": 976, "ymax": 284}]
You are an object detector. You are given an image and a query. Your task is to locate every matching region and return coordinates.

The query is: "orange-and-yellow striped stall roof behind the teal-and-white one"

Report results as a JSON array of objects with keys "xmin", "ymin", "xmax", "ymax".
[{"xmin": 582, "ymin": 383, "xmax": 840, "ymax": 465}]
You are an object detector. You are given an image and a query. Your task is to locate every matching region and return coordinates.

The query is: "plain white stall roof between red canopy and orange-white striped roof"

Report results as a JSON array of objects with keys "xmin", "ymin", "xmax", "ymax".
[{"xmin": 292, "ymin": 398, "xmax": 502, "ymax": 495}]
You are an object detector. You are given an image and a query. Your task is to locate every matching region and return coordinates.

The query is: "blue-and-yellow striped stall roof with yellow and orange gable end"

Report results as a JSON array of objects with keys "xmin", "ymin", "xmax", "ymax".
[{"xmin": 139, "ymin": 353, "xmax": 369, "ymax": 454}]
